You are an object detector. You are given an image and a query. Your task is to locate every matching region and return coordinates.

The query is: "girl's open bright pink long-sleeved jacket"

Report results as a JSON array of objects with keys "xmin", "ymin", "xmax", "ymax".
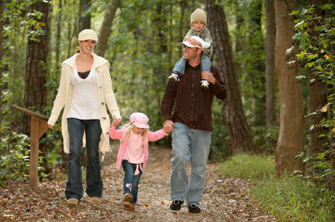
[{"xmin": 109, "ymin": 126, "xmax": 169, "ymax": 171}]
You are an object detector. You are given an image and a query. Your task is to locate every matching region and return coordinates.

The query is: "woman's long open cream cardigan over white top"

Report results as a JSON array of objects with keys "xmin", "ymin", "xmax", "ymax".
[{"xmin": 48, "ymin": 53, "xmax": 121, "ymax": 153}]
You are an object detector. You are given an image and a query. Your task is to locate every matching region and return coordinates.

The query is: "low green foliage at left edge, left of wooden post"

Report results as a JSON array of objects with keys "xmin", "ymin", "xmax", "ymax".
[{"xmin": 0, "ymin": 125, "xmax": 30, "ymax": 185}]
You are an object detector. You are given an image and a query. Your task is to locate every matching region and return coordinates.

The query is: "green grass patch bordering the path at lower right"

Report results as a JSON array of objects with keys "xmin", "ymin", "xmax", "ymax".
[{"xmin": 218, "ymin": 155, "xmax": 335, "ymax": 221}]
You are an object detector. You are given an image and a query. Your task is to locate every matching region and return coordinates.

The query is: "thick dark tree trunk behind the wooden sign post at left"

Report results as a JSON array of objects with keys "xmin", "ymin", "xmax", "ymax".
[{"xmin": 23, "ymin": 0, "xmax": 50, "ymax": 135}]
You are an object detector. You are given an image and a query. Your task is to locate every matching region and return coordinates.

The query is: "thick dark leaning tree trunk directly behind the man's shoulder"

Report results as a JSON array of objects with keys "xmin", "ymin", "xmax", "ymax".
[{"xmin": 206, "ymin": 0, "xmax": 253, "ymax": 154}]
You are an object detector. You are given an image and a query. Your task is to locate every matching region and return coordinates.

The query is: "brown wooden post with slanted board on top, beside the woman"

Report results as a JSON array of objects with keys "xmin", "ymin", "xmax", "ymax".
[{"xmin": 12, "ymin": 105, "xmax": 49, "ymax": 188}]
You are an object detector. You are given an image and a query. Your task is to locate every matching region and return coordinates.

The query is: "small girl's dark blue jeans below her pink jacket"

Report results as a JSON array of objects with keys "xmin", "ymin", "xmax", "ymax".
[{"xmin": 122, "ymin": 160, "xmax": 142, "ymax": 203}]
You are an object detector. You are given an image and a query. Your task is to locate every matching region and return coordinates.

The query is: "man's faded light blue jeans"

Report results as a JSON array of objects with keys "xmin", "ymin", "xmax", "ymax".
[{"xmin": 171, "ymin": 123, "xmax": 211, "ymax": 207}]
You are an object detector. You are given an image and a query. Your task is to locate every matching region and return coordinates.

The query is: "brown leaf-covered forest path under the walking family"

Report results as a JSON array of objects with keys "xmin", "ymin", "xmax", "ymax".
[{"xmin": 0, "ymin": 144, "xmax": 276, "ymax": 222}]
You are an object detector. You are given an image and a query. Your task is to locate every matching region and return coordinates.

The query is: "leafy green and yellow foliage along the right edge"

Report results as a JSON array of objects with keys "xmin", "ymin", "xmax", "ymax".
[{"xmin": 294, "ymin": 4, "xmax": 335, "ymax": 187}]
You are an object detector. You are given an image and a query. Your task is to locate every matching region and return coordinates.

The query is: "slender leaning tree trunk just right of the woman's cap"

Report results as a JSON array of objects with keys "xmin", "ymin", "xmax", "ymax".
[{"xmin": 96, "ymin": 0, "xmax": 121, "ymax": 56}]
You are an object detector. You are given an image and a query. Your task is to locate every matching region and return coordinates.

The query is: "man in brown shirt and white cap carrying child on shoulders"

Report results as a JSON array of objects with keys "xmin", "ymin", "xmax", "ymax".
[{"xmin": 161, "ymin": 36, "xmax": 226, "ymax": 213}]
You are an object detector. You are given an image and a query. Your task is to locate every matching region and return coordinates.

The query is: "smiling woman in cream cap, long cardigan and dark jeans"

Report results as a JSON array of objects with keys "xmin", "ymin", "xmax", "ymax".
[{"xmin": 48, "ymin": 29, "xmax": 121, "ymax": 208}]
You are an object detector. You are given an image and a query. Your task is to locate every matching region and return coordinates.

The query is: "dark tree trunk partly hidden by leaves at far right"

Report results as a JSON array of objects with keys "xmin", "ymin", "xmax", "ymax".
[{"xmin": 307, "ymin": 0, "xmax": 328, "ymax": 154}]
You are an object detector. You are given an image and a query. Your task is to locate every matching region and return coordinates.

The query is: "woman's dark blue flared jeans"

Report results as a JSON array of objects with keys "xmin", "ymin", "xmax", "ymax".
[{"xmin": 65, "ymin": 118, "xmax": 103, "ymax": 200}]
